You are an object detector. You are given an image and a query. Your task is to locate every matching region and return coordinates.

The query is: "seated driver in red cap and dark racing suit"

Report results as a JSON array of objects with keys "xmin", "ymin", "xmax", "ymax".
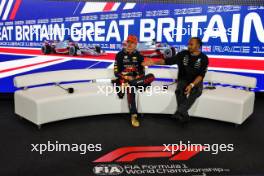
[{"xmin": 114, "ymin": 35, "xmax": 145, "ymax": 127}]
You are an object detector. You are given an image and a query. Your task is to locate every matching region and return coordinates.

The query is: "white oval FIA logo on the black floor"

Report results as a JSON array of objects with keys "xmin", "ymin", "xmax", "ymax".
[{"xmin": 93, "ymin": 164, "xmax": 124, "ymax": 175}]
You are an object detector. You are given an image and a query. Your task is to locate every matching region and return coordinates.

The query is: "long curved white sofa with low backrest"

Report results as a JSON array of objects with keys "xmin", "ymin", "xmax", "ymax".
[{"xmin": 14, "ymin": 68, "xmax": 256, "ymax": 127}]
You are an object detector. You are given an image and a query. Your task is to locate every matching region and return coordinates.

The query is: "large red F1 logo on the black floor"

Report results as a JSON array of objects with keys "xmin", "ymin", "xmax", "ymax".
[{"xmin": 93, "ymin": 146, "xmax": 202, "ymax": 163}]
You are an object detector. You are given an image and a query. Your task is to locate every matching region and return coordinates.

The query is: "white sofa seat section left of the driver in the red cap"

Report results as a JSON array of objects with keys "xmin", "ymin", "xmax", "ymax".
[{"xmin": 15, "ymin": 83, "xmax": 128, "ymax": 124}]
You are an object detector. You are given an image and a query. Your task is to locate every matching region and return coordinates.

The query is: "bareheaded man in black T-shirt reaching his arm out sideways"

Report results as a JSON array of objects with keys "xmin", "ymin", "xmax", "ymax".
[{"xmin": 143, "ymin": 37, "xmax": 208, "ymax": 123}]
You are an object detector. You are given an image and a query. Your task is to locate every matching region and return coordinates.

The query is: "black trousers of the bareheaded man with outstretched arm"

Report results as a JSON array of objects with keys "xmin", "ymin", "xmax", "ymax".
[{"xmin": 175, "ymin": 80, "xmax": 203, "ymax": 115}]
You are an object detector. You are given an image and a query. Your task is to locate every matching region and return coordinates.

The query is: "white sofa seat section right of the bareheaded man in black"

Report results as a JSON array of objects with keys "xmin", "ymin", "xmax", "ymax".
[{"xmin": 189, "ymin": 87, "xmax": 255, "ymax": 124}]
